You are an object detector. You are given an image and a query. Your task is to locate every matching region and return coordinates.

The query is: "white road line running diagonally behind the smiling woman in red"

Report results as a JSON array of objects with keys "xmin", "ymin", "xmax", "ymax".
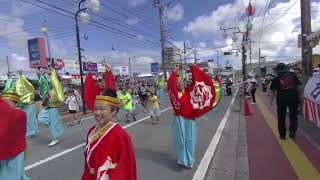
[{"xmin": 24, "ymin": 107, "xmax": 172, "ymax": 171}]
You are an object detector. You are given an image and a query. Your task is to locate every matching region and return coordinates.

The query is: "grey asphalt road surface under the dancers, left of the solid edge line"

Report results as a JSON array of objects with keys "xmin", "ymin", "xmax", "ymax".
[{"xmin": 26, "ymin": 91, "xmax": 232, "ymax": 180}]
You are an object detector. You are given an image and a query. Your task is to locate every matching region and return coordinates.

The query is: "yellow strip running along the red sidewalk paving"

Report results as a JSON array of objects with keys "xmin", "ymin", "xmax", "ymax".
[{"xmin": 256, "ymin": 97, "xmax": 320, "ymax": 180}]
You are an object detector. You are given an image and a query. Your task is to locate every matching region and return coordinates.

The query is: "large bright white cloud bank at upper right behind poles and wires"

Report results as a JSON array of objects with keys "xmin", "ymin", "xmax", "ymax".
[{"xmin": 183, "ymin": 0, "xmax": 320, "ymax": 68}]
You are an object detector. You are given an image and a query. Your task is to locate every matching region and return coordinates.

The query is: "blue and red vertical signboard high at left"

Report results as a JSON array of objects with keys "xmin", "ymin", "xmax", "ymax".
[{"xmin": 28, "ymin": 37, "xmax": 48, "ymax": 68}]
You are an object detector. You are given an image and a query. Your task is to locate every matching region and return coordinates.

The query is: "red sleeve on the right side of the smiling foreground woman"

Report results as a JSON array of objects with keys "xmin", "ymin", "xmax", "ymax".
[{"xmin": 109, "ymin": 134, "xmax": 137, "ymax": 180}]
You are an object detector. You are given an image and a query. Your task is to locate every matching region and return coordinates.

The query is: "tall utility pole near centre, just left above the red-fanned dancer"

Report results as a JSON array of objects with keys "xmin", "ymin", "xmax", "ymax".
[{"xmin": 153, "ymin": 0, "xmax": 167, "ymax": 81}]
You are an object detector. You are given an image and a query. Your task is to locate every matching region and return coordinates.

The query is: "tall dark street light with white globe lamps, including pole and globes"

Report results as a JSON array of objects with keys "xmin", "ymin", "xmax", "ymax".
[{"xmin": 75, "ymin": 0, "xmax": 100, "ymax": 114}]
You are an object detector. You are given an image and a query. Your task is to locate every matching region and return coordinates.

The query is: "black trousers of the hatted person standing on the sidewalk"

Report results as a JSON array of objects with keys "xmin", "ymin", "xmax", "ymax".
[{"xmin": 277, "ymin": 100, "xmax": 298, "ymax": 137}]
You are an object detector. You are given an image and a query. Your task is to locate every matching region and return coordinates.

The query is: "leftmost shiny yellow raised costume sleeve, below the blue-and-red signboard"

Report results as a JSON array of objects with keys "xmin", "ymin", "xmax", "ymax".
[{"xmin": 16, "ymin": 75, "xmax": 34, "ymax": 104}]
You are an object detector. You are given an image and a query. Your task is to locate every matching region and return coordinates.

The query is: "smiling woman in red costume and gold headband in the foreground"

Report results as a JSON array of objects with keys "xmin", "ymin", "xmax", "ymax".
[{"xmin": 82, "ymin": 66, "xmax": 137, "ymax": 180}]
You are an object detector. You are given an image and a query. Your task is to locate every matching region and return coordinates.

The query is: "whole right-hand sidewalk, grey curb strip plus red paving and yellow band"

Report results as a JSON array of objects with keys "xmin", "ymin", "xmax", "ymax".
[{"xmin": 205, "ymin": 93, "xmax": 320, "ymax": 180}]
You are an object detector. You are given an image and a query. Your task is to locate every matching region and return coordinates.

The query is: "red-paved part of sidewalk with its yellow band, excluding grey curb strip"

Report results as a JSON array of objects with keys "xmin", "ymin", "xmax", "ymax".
[{"xmin": 246, "ymin": 92, "xmax": 320, "ymax": 180}]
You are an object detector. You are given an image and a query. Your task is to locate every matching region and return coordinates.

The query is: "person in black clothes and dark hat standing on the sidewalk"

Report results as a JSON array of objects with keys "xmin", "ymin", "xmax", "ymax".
[{"xmin": 270, "ymin": 63, "xmax": 301, "ymax": 140}]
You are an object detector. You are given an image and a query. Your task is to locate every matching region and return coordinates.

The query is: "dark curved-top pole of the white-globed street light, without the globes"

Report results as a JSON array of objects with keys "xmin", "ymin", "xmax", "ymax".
[{"xmin": 75, "ymin": 0, "xmax": 87, "ymax": 114}]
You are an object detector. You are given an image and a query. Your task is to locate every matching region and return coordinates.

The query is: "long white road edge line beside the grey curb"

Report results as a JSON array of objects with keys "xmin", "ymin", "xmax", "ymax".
[{"xmin": 192, "ymin": 88, "xmax": 239, "ymax": 180}]
